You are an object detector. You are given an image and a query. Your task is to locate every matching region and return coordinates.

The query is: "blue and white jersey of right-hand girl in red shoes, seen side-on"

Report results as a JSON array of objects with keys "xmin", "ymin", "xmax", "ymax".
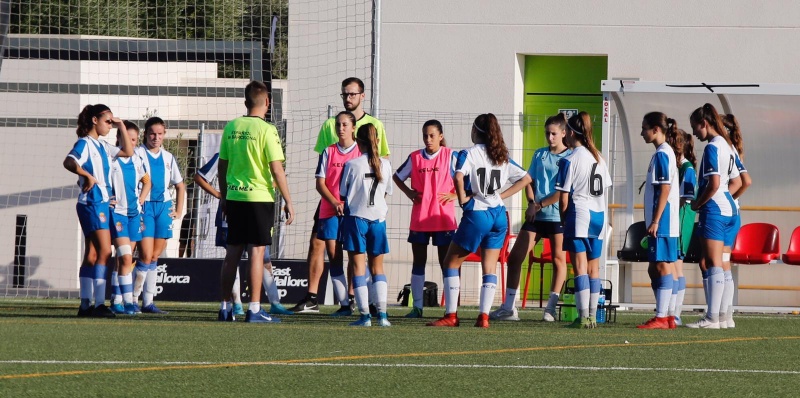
[{"xmin": 644, "ymin": 142, "xmax": 680, "ymax": 238}]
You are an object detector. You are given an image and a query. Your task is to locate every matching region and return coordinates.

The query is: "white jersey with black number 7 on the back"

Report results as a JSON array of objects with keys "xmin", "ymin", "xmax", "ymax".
[{"xmin": 339, "ymin": 154, "xmax": 394, "ymax": 221}]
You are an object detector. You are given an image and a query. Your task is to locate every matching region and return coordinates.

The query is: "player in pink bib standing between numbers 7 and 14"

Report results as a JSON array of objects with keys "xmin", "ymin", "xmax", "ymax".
[{"xmin": 392, "ymin": 120, "xmax": 458, "ymax": 318}]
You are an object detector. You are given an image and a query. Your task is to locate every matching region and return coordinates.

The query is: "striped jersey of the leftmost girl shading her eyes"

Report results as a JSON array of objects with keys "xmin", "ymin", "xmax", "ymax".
[{"xmin": 67, "ymin": 135, "xmax": 120, "ymax": 205}]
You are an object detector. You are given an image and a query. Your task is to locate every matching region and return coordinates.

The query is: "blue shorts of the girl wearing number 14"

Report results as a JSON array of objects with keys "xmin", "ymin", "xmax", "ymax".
[{"xmin": 453, "ymin": 206, "xmax": 508, "ymax": 253}]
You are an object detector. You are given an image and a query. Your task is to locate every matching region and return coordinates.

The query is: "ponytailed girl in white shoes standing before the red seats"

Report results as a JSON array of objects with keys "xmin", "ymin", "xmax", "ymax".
[{"xmin": 686, "ymin": 104, "xmax": 742, "ymax": 329}]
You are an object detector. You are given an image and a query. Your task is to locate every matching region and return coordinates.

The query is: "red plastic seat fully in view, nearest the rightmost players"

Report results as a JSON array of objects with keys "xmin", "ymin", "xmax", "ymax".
[{"xmin": 731, "ymin": 223, "xmax": 781, "ymax": 264}]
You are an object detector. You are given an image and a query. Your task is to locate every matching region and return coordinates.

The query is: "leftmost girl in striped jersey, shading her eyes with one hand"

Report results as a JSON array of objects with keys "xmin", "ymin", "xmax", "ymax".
[{"xmin": 64, "ymin": 104, "xmax": 133, "ymax": 317}]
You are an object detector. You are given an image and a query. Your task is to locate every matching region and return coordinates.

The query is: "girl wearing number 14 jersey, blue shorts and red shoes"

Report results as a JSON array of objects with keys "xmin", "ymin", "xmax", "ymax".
[{"xmin": 427, "ymin": 113, "xmax": 531, "ymax": 328}]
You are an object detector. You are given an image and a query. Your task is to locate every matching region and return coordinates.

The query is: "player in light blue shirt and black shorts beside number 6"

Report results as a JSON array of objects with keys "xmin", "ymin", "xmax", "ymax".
[{"xmin": 489, "ymin": 113, "xmax": 572, "ymax": 322}]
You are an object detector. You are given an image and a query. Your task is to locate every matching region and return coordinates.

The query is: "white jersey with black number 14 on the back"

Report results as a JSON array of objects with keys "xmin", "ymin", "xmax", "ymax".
[{"xmin": 456, "ymin": 144, "xmax": 528, "ymax": 211}]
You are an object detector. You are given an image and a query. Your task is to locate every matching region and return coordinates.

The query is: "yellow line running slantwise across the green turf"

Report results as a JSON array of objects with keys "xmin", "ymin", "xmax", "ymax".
[{"xmin": 0, "ymin": 336, "xmax": 800, "ymax": 380}]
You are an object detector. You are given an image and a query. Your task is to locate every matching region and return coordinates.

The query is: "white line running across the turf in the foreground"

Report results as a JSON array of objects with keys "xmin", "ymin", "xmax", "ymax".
[{"xmin": 0, "ymin": 360, "xmax": 800, "ymax": 375}]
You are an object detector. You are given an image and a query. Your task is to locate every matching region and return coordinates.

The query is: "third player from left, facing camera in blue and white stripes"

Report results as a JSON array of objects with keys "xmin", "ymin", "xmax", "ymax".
[{"xmin": 133, "ymin": 116, "xmax": 186, "ymax": 314}]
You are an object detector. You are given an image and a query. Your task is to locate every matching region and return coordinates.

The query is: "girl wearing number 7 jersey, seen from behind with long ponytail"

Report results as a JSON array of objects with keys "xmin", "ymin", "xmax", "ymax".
[{"xmin": 339, "ymin": 124, "xmax": 392, "ymax": 326}]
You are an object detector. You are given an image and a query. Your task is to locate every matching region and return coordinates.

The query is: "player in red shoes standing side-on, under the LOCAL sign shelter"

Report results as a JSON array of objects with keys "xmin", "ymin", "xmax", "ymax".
[{"xmin": 637, "ymin": 112, "xmax": 683, "ymax": 329}]
